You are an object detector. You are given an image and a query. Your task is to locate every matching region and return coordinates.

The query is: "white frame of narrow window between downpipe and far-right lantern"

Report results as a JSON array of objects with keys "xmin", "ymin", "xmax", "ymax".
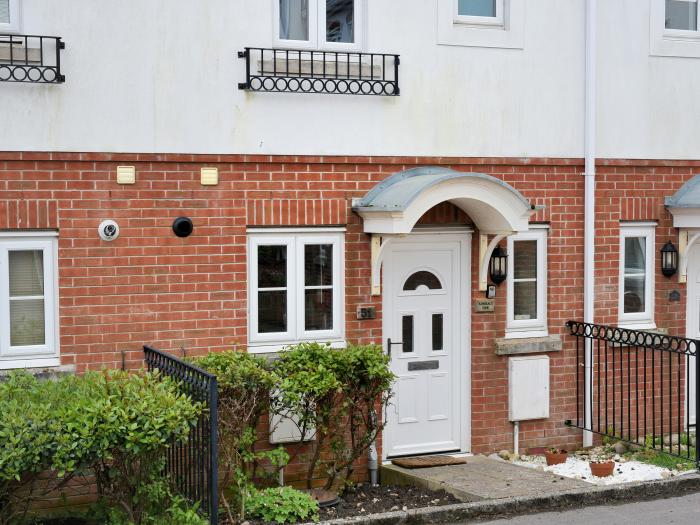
[{"xmin": 618, "ymin": 222, "xmax": 656, "ymax": 329}]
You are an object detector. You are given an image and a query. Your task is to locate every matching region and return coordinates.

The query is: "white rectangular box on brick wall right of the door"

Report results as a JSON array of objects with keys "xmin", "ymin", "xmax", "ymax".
[{"xmin": 508, "ymin": 355, "xmax": 549, "ymax": 421}]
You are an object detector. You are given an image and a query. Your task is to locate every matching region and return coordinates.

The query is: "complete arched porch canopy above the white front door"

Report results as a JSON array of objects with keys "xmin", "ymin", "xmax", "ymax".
[{"xmin": 353, "ymin": 167, "xmax": 536, "ymax": 235}]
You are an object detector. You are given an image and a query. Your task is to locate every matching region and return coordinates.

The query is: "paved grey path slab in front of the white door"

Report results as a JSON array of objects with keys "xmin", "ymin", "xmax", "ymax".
[{"xmin": 381, "ymin": 456, "xmax": 591, "ymax": 503}]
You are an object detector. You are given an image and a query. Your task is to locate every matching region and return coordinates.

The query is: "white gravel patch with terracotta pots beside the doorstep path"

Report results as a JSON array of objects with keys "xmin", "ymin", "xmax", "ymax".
[{"xmin": 513, "ymin": 456, "xmax": 673, "ymax": 485}]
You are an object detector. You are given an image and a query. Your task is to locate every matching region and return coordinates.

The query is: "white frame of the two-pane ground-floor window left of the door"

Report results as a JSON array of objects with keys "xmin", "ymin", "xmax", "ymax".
[{"xmin": 248, "ymin": 228, "xmax": 345, "ymax": 353}]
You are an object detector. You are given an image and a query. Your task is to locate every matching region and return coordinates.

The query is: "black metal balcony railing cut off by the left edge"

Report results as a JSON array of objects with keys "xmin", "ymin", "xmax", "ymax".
[{"xmin": 0, "ymin": 34, "xmax": 66, "ymax": 84}]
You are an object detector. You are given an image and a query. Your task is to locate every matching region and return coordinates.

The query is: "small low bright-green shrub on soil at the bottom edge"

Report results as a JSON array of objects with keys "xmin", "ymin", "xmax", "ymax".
[{"xmin": 247, "ymin": 487, "xmax": 318, "ymax": 523}]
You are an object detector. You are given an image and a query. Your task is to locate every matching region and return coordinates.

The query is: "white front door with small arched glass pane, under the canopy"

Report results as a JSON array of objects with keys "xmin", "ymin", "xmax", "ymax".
[{"xmin": 382, "ymin": 233, "xmax": 471, "ymax": 457}]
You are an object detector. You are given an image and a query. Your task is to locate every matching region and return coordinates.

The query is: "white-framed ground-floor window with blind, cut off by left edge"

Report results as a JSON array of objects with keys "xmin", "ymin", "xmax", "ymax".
[{"xmin": 0, "ymin": 233, "xmax": 59, "ymax": 369}]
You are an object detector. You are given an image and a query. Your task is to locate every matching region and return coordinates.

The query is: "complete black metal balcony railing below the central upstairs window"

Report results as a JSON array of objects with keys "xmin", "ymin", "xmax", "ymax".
[{"xmin": 238, "ymin": 47, "xmax": 400, "ymax": 96}]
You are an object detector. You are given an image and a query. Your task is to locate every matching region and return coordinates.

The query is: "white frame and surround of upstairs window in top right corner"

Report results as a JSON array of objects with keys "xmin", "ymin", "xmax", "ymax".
[{"xmin": 649, "ymin": 0, "xmax": 700, "ymax": 58}]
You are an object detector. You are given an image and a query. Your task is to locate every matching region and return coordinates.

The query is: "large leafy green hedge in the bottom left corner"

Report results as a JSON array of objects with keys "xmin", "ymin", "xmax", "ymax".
[{"xmin": 0, "ymin": 371, "xmax": 201, "ymax": 524}]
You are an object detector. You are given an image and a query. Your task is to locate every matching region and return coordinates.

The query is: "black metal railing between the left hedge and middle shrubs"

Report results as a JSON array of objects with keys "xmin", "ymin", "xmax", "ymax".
[{"xmin": 143, "ymin": 346, "xmax": 219, "ymax": 525}]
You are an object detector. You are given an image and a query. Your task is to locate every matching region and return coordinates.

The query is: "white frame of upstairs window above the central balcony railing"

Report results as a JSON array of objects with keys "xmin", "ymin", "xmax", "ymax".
[{"xmin": 272, "ymin": 0, "xmax": 367, "ymax": 51}]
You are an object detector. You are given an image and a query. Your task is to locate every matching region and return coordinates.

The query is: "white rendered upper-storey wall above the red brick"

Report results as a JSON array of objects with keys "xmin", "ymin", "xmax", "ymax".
[{"xmin": 0, "ymin": 0, "xmax": 700, "ymax": 158}]
